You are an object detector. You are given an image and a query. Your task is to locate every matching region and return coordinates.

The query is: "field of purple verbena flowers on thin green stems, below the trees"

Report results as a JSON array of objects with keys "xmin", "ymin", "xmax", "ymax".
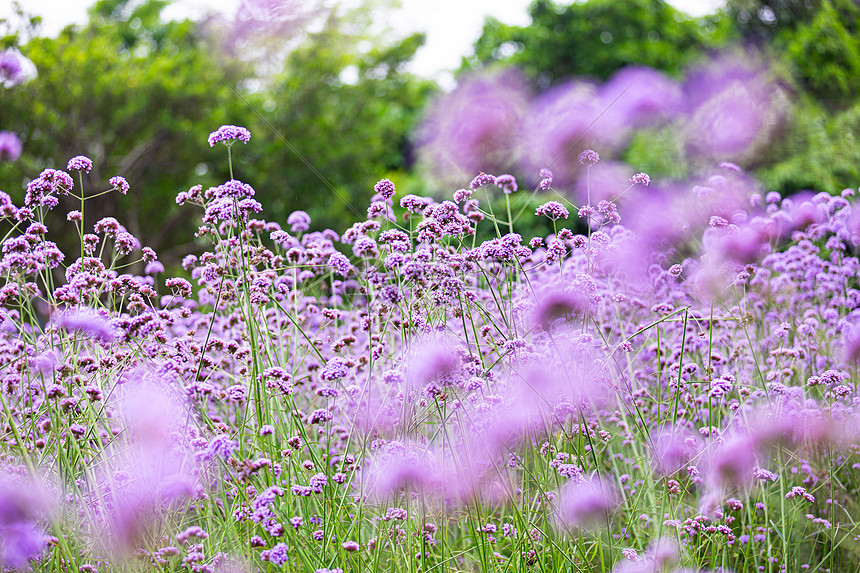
[{"xmin": 0, "ymin": 126, "xmax": 860, "ymax": 573}]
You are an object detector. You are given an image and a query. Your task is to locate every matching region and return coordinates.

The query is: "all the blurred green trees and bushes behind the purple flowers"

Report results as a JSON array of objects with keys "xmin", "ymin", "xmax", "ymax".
[{"xmin": 0, "ymin": 0, "xmax": 860, "ymax": 265}]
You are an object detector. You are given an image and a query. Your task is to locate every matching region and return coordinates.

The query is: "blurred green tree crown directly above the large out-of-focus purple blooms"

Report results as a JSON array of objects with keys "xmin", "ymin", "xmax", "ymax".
[{"xmin": 466, "ymin": 0, "xmax": 731, "ymax": 88}]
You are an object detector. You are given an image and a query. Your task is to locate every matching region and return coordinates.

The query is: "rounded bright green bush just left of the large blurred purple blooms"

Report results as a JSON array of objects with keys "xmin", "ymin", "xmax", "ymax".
[{"xmin": 243, "ymin": 7, "xmax": 436, "ymax": 228}]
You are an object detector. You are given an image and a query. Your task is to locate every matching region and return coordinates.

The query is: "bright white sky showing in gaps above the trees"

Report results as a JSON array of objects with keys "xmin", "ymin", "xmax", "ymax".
[{"xmin": 0, "ymin": 0, "xmax": 724, "ymax": 84}]
